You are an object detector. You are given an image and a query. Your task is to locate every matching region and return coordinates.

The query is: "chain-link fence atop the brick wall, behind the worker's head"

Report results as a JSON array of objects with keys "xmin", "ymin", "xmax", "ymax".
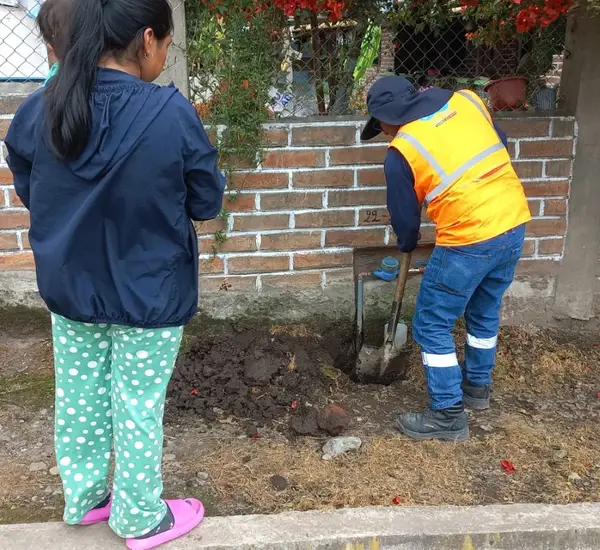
[{"xmin": 190, "ymin": 13, "xmax": 565, "ymax": 118}]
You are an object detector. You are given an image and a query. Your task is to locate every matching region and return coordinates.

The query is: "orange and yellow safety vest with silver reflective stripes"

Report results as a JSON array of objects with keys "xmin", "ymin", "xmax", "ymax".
[{"xmin": 390, "ymin": 90, "xmax": 531, "ymax": 246}]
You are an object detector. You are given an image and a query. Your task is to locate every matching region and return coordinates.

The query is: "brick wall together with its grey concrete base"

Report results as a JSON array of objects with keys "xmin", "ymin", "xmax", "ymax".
[{"xmin": 0, "ymin": 115, "xmax": 576, "ymax": 326}]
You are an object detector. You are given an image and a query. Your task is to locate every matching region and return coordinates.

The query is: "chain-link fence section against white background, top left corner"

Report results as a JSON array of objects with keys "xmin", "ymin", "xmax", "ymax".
[{"xmin": 0, "ymin": 0, "xmax": 49, "ymax": 85}]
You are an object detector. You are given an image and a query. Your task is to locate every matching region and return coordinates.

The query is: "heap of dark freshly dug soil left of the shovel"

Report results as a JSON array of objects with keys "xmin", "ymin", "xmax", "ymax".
[{"xmin": 168, "ymin": 326, "xmax": 353, "ymax": 435}]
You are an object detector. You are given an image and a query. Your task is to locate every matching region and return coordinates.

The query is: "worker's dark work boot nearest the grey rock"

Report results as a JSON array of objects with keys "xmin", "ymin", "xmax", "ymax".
[{"xmin": 396, "ymin": 405, "xmax": 469, "ymax": 441}]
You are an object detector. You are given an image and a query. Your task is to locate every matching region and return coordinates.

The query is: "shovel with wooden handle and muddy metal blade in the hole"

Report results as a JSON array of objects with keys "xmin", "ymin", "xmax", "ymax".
[{"xmin": 356, "ymin": 253, "xmax": 411, "ymax": 381}]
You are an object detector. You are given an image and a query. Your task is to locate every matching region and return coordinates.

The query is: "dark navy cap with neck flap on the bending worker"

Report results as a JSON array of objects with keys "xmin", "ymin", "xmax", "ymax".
[{"xmin": 360, "ymin": 76, "xmax": 453, "ymax": 141}]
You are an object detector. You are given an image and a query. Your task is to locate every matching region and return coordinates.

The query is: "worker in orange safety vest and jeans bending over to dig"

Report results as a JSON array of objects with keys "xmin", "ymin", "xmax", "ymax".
[{"xmin": 361, "ymin": 76, "xmax": 531, "ymax": 441}]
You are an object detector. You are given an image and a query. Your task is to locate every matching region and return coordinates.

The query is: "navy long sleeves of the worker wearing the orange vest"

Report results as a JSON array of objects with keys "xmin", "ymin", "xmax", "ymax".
[{"xmin": 384, "ymin": 124, "xmax": 508, "ymax": 252}]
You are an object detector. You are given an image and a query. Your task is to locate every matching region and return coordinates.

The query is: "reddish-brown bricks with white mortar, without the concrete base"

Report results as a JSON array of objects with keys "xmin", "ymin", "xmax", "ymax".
[{"xmin": 0, "ymin": 116, "xmax": 575, "ymax": 302}]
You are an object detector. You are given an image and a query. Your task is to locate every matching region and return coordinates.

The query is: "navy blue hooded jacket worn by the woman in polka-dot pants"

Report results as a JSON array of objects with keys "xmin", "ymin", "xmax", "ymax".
[{"xmin": 6, "ymin": 69, "xmax": 225, "ymax": 328}]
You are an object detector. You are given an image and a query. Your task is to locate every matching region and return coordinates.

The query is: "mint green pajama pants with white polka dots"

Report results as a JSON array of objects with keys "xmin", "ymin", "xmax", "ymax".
[{"xmin": 52, "ymin": 315, "xmax": 183, "ymax": 538}]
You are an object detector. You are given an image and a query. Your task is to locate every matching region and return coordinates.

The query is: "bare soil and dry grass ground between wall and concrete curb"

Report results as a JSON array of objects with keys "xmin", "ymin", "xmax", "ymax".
[{"xmin": 0, "ymin": 313, "xmax": 600, "ymax": 523}]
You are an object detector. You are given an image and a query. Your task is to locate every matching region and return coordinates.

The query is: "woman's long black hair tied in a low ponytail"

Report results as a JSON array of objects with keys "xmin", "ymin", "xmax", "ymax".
[{"xmin": 45, "ymin": 0, "xmax": 173, "ymax": 159}]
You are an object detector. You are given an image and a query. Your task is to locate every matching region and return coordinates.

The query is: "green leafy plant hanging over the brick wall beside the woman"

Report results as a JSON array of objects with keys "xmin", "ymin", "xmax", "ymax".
[{"xmin": 186, "ymin": 0, "xmax": 284, "ymax": 254}]
